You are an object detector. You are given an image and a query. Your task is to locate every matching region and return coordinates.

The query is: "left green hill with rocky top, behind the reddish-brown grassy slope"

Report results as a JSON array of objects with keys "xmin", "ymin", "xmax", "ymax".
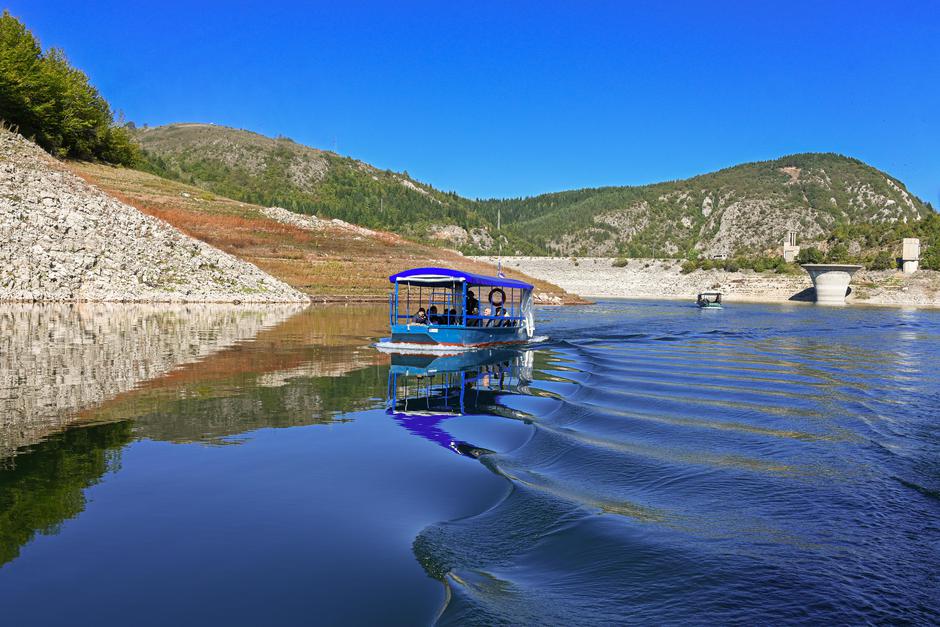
[{"xmin": 134, "ymin": 124, "xmax": 527, "ymax": 251}]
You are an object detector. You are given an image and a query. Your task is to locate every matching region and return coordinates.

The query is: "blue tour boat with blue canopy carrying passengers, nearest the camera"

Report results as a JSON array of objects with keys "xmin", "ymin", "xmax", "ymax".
[{"xmin": 382, "ymin": 268, "xmax": 535, "ymax": 350}]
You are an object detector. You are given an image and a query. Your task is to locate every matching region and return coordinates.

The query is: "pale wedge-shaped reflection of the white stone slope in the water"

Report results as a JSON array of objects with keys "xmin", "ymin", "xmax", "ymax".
[{"xmin": 0, "ymin": 304, "xmax": 301, "ymax": 456}]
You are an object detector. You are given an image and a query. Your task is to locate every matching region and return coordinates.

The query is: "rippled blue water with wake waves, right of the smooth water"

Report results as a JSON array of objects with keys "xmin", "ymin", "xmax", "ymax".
[{"xmin": 414, "ymin": 302, "xmax": 940, "ymax": 625}]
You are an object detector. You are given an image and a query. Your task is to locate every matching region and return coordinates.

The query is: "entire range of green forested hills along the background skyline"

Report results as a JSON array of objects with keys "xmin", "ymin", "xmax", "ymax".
[{"xmin": 135, "ymin": 124, "xmax": 932, "ymax": 257}]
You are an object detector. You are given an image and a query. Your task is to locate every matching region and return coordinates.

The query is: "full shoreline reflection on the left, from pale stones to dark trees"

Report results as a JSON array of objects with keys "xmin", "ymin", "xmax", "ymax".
[{"xmin": 0, "ymin": 306, "xmax": 388, "ymax": 565}]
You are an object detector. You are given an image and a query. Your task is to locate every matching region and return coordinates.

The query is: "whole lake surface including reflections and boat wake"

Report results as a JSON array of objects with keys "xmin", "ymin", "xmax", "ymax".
[{"xmin": 0, "ymin": 302, "xmax": 940, "ymax": 625}]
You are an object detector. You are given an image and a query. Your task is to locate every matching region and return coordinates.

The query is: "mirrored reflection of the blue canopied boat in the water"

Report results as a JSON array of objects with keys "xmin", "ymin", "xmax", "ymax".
[{"xmin": 386, "ymin": 349, "xmax": 532, "ymax": 457}]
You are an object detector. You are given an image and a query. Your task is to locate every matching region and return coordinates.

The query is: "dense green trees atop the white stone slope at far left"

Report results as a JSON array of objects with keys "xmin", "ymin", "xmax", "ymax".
[{"xmin": 0, "ymin": 11, "xmax": 137, "ymax": 165}]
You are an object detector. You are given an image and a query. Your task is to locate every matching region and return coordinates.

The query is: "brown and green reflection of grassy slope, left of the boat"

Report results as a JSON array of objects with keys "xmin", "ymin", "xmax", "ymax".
[{"xmin": 82, "ymin": 305, "xmax": 388, "ymax": 442}]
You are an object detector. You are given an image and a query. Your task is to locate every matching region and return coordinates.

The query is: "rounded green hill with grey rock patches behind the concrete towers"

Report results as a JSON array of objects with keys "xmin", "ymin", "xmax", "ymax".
[{"xmin": 478, "ymin": 153, "xmax": 932, "ymax": 257}]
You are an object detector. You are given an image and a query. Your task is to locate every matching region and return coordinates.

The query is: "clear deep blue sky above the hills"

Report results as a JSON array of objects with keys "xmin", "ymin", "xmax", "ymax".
[{"xmin": 6, "ymin": 0, "xmax": 940, "ymax": 206}]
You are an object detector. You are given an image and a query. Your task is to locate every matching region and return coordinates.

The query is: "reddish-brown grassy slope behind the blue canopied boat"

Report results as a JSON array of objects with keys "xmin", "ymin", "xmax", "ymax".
[{"xmin": 68, "ymin": 162, "xmax": 580, "ymax": 303}]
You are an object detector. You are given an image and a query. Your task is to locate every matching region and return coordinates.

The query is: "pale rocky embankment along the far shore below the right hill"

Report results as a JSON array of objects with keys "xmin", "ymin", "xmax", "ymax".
[{"xmin": 477, "ymin": 257, "xmax": 940, "ymax": 307}]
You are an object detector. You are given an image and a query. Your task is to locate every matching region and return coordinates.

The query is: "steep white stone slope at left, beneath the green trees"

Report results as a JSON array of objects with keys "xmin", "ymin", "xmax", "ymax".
[{"xmin": 0, "ymin": 129, "xmax": 309, "ymax": 303}]
